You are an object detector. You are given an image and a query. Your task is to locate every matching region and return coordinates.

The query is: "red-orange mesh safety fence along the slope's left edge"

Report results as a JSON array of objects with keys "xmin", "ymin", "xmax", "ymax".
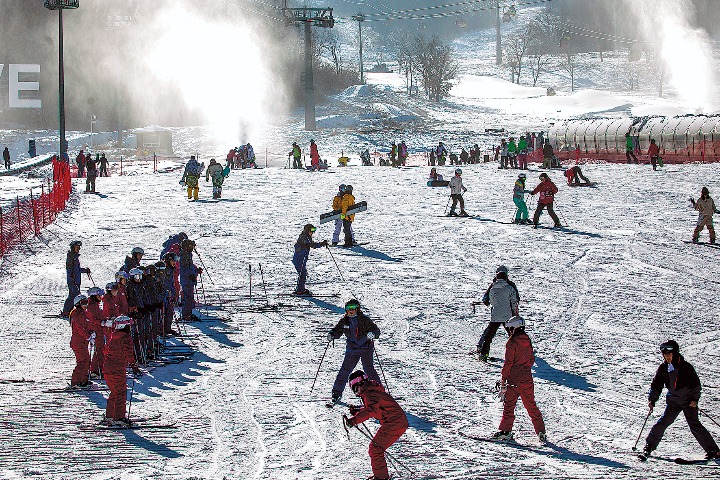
[{"xmin": 0, "ymin": 157, "xmax": 72, "ymax": 256}]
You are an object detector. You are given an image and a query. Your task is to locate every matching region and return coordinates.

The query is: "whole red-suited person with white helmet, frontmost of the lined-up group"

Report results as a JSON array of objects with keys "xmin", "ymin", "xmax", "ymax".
[{"xmin": 103, "ymin": 315, "xmax": 142, "ymax": 427}]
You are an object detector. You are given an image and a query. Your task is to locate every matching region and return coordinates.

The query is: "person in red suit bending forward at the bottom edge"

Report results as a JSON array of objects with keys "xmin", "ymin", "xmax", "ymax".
[{"xmin": 345, "ymin": 370, "xmax": 408, "ymax": 480}]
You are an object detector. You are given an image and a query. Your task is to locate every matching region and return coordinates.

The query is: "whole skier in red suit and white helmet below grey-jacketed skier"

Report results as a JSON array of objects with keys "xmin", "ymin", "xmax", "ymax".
[{"xmin": 493, "ymin": 315, "xmax": 547, "ymax": 443}]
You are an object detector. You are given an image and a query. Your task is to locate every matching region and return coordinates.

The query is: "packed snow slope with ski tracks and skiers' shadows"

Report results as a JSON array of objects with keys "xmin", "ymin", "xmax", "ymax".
[{"xmin": 0, "ymin": 159, "xmax": 720, "ymax": 479}]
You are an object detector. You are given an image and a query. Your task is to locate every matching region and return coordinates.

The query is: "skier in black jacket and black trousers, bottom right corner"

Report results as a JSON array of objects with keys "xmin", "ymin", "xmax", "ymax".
[{"xmin": 641, "ymin": 340, "xmax": 720, "ymax": 459}]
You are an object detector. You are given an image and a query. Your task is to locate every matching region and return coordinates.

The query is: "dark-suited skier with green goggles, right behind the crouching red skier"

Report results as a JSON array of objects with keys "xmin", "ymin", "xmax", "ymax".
[{"xmin": 328, "ymin": 299, "xmax": 382, "ymax": 402}]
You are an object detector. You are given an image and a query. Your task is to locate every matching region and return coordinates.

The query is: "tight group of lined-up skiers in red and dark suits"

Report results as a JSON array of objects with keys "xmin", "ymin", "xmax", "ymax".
[{"xmin": 63, "ymin": 232, "xmax": 202, "ymax": 426}]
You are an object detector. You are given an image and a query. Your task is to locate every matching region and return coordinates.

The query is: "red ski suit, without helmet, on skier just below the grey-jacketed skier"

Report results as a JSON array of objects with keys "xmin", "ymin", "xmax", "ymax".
[{"xmin": 500, "ymin": 331, "xmax": 545, "ymax": 433}]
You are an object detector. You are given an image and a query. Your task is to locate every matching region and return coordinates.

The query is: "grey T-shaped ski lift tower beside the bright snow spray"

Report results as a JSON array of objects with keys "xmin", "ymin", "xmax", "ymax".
[{"xmin": 283, "ymin": 0, "xmax": 335, "ymax": 130}]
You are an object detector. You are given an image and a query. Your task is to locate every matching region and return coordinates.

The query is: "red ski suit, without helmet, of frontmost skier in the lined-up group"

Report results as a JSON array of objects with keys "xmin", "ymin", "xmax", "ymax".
[{"xmin": 103, "ymin": 330, "xmax": 137, "ymax": 420}]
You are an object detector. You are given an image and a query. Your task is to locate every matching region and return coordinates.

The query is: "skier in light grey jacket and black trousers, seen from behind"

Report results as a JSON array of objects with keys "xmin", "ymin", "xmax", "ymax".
[{"xmin": 472, "ymin": 265, "xmax": 520, "ymax": 362}]
